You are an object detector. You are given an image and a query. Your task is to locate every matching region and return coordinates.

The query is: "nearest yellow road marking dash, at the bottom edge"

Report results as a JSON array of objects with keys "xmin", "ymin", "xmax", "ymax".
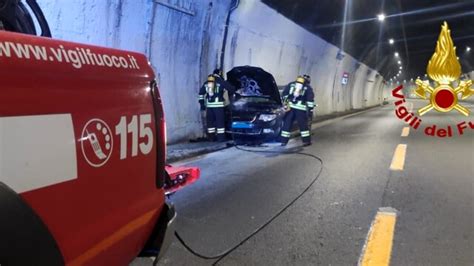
[{"xmin": 359, "ymin": 210, "xmax": 397, "ymax": 266}]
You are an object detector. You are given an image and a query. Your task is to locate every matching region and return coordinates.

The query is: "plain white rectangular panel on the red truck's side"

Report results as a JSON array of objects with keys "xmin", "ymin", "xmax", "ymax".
[{"xmin": 0, "ymin": 114, "xmax": 77, "ymax": 193}]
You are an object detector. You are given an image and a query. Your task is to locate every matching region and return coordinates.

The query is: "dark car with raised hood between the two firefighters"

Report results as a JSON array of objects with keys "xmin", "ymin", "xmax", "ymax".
[{"xmin": 227, "ymin": 66, "xmax": 285, "ymax": 143}]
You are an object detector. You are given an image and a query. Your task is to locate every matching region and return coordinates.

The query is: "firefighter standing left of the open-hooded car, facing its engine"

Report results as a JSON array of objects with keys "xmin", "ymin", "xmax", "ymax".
[{"xmin": 199, "ymin": 75, "xmax": 232, "ymax": 141}]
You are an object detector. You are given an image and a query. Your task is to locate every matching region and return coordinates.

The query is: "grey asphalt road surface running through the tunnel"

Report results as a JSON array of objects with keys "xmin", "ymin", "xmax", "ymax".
[{"xmin": 132, "ymin": 101, "xmax": 474, "ymax": 265}]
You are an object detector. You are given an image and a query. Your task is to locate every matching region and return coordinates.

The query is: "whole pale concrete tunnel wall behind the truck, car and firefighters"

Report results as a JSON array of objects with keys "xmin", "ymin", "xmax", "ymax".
[{"xmin": 38, "ymin": 0, "xmax": 389, "ymax": 143}]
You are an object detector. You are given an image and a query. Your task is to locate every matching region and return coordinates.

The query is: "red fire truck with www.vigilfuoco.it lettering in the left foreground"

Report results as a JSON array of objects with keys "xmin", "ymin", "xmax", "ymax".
[{"xmin": 0, "ymin": 0, "xmax": 199, "ymax": 266}]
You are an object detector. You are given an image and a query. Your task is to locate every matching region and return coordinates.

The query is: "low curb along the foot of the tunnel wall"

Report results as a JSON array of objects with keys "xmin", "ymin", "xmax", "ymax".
[{"xmin": 166, "ymin": 105, "xmax": 383, "ymax": 163}]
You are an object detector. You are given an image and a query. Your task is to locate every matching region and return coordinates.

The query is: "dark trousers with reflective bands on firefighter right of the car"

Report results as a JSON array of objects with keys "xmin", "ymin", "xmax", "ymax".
[{"xmin": 281, "ymin": 109, "xmax": 311, "ymax": 144}]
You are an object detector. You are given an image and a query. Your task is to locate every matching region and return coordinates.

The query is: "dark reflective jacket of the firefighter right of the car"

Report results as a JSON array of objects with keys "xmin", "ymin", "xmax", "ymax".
[{"xmin": 283, "ymin": 82, "xmax": 314, "ymax": 112}]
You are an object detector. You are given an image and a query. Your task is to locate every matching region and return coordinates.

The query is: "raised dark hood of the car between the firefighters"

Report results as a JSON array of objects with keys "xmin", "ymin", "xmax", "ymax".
[{"xmin": 227, "ymin": 66, "xmax": 281, "ymax": 104}]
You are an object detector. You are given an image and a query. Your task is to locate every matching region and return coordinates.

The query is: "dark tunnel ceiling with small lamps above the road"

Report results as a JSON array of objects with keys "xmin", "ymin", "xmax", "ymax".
[{"xmin": 263, "ymin": 0, "xmax": 474, "ymax": 80}]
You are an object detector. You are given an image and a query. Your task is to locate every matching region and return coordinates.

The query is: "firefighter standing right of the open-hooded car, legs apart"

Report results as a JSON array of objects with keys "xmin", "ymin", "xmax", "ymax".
[{"xmin": 281, "ymin": 75, "xmax": 314, "ymax": 146}]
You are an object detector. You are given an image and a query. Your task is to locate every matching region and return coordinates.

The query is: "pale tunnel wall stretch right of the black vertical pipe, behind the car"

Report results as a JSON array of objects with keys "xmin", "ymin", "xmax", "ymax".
[{"xmin": 225, "ymin": 0, "xmax": 383, "ymax": 115}]
